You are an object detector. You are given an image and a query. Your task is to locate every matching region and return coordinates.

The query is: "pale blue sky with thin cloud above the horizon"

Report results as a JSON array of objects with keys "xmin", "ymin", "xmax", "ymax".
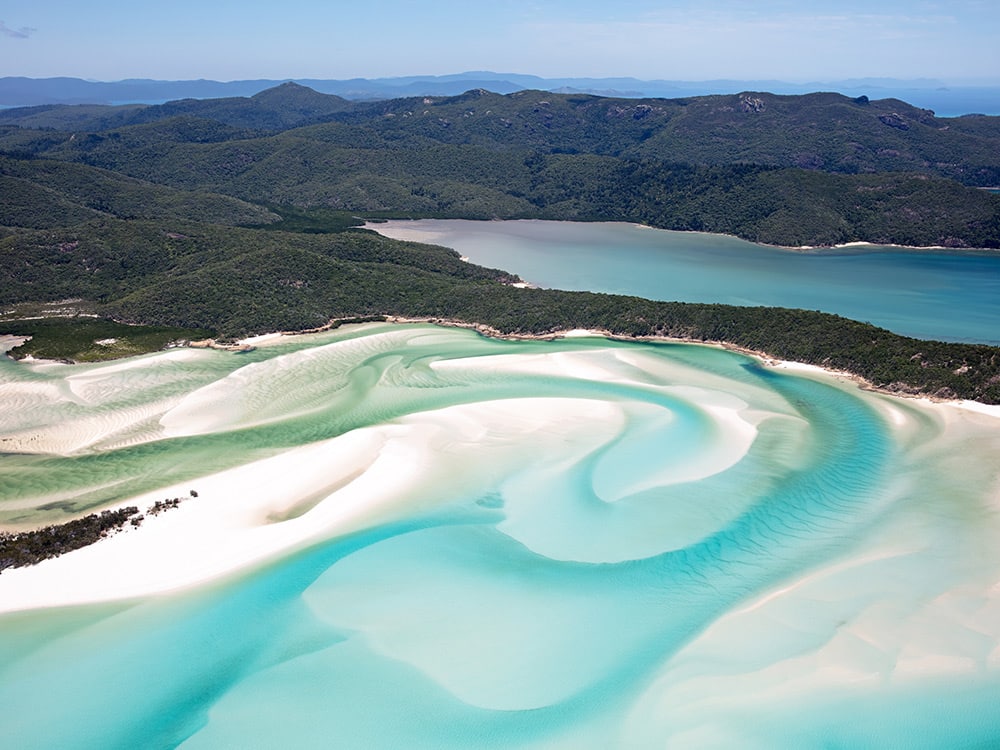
[{"xmin": 0, "ymin": 0, "xmax": 1000, "ymax": 83}]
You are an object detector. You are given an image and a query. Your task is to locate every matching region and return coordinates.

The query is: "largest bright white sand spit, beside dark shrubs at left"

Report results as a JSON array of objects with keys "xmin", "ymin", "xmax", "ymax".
[{"xmin": 0, "ymin": 399, "xmax": 621, "ymax": 612}]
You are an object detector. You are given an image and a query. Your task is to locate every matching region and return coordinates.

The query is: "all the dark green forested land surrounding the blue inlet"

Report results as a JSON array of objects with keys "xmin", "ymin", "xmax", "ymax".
[{"xmin": 0, "ymin": 83, "xmax": 1000, "ymax": 403}]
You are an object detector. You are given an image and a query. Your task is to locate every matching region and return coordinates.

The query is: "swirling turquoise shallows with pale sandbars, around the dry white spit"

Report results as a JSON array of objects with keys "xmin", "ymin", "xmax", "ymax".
[{"xmin": 0, "ymin": 324, "xmax": 1000, "ymax": 748}]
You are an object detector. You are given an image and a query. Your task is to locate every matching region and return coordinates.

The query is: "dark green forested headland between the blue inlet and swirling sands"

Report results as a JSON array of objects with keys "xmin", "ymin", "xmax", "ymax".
[{"xmin": 0, "ymin": 223, "xmax": 1000, "ymax": 403}]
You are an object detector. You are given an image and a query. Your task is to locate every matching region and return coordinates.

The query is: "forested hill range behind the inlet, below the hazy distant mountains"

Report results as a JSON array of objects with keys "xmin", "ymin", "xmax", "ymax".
[{"xmin": 0, "ymin": 83, "xmax": 1000, "ymax": 247}]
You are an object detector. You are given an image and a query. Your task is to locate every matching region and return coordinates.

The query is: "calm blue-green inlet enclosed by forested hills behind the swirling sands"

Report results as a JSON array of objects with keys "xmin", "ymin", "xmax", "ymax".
[{"xmin": 372, "ymin": 220, "xmax": 1000, "ymax": 344}]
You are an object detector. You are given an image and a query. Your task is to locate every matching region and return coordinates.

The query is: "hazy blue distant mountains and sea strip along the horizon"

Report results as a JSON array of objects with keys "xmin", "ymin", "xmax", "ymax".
[{"xmin": 0, "ymin": 71, "xmax": 1000, "ymax": 117}]
